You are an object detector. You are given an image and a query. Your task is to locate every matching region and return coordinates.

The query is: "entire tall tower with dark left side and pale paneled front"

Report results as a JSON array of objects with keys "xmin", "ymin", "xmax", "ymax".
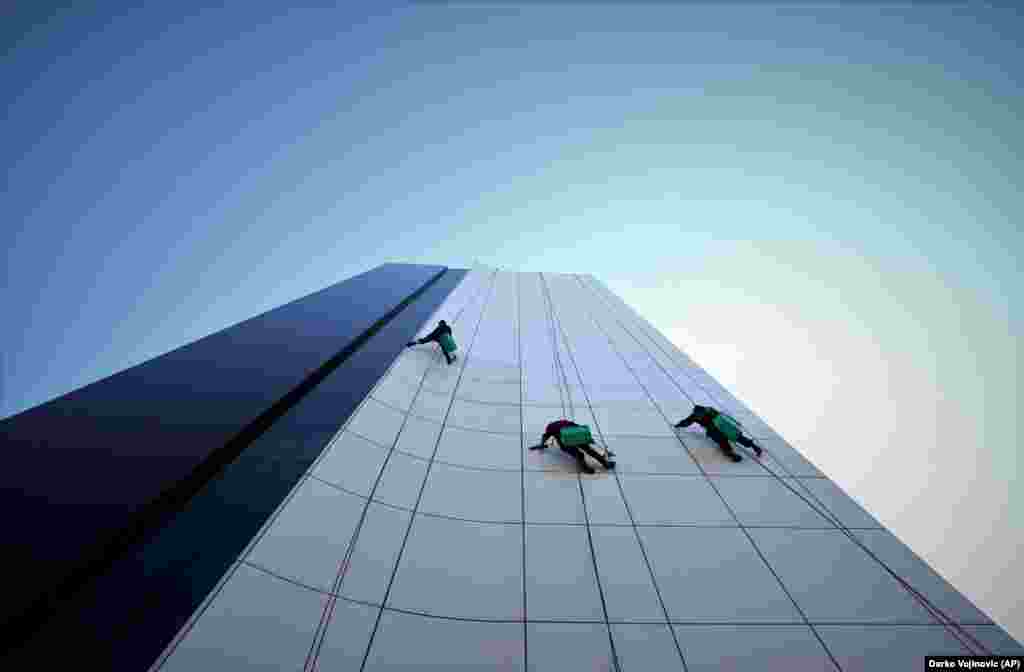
[{"xmin": 0, "ymin": 264, "xmax": 1024, "ymax": 671}]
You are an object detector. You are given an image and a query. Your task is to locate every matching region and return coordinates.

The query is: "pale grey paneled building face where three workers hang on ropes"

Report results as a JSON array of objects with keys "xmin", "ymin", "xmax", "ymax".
[{"xmin": 4, "ymin": 268, "xmax": 1024, "ymax": 672}]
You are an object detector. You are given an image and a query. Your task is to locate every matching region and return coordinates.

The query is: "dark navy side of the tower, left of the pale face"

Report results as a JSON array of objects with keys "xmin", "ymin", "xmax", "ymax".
[{"xmin": 0, "ymin": 264, "xmax": 465, "ymax": 670}]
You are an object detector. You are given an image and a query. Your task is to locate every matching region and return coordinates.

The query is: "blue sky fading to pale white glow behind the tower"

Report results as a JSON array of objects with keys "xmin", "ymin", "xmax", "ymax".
[{"xmin": 0, "ymin": 2, "xmax": 1024, "ymax": 639}]
